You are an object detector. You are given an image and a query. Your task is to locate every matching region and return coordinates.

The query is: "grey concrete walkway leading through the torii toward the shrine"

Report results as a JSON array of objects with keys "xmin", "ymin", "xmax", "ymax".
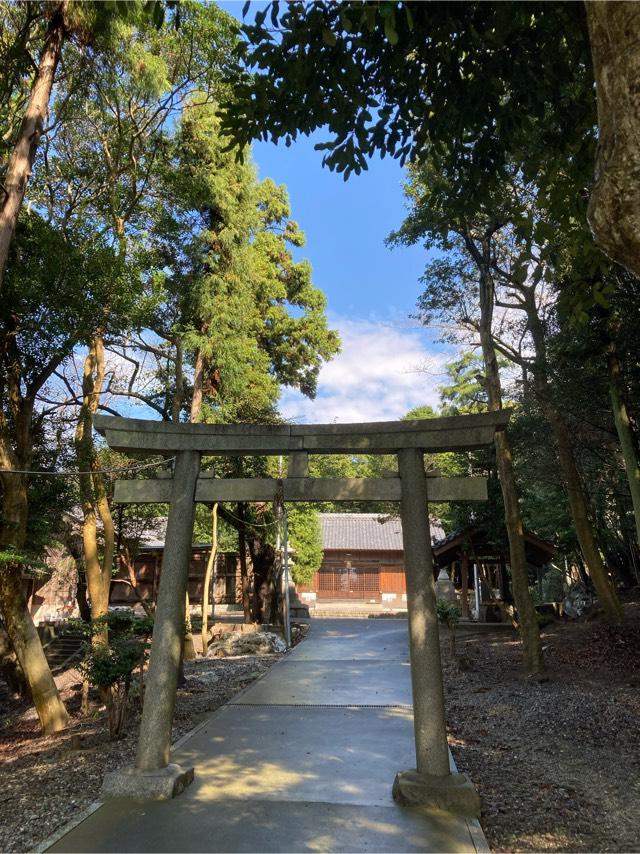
[{"xmin": 48, "ymin": 619, "xmax": 488, "ymax": 852}]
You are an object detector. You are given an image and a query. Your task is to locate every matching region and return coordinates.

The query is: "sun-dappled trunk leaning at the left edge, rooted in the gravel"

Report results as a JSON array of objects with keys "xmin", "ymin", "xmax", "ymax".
[{"xmin": 0, "ymin": 474, "xmax": 69, "ymax": 735}]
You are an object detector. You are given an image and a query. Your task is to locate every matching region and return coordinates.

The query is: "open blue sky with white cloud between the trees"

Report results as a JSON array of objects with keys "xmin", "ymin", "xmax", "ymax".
[{"xmin": 220, "ymin": 0, "xmax": 451, "ymax": 422}]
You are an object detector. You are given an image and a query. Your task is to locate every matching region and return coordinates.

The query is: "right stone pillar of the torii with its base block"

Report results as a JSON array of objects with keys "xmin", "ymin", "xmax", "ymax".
[{"xmin": 393, "ymin": 448, "xmax": 480, "ymax": 817}]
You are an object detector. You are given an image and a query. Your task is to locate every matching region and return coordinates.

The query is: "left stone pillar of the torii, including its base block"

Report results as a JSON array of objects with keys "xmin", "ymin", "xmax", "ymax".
[{"xmin": 101, "ymin": 451, "xmax": 200, "ymax": 800}]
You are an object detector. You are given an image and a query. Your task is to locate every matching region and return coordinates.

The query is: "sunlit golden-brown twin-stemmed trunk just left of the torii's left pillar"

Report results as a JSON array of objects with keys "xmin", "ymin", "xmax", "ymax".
[{"xmin": 75, "ymin": 333, "xmax": 115, "ymax": 644}]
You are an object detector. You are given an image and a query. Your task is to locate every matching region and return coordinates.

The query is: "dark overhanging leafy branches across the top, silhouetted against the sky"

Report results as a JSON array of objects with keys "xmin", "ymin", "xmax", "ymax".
[{"xmin": 224, "ymin": 0, "xmax": 596, "ymax": 214}]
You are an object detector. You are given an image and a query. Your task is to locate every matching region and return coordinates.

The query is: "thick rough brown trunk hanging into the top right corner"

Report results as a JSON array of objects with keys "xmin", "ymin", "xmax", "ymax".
[{"xmin": 586, "ymin": 0, "xmax": 640, "ymax": 276}]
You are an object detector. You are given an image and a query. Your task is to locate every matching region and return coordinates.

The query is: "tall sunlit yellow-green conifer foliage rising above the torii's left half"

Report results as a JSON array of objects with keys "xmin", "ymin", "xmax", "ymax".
[{"xmin": 156, "ymin": 99, "xmax": 339, "ymax": 422}]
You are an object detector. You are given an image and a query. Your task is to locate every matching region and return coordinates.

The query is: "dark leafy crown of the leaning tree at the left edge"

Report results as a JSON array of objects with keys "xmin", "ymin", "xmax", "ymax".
[{"xmin": 0, "ymin": 211, "xmax": 141, "ymax": 562}]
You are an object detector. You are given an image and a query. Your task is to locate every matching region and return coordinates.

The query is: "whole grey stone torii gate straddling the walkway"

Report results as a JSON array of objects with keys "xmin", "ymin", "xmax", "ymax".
[{"xmin": 95, "ymin": 410, "xmax": 510, "ymax": 815}]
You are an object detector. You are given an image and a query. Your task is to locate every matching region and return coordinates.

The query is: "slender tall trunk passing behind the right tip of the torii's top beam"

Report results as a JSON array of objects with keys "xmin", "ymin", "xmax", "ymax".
[{"xmin": 468, "ymin": 244, "xmax": 545, "ymax": 679}]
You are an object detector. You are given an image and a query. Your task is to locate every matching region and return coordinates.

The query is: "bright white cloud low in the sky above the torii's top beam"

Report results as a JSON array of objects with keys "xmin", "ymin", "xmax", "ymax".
[{"xmin": 280, "ymin": 319, "xmax": 453, "ymax": 423}]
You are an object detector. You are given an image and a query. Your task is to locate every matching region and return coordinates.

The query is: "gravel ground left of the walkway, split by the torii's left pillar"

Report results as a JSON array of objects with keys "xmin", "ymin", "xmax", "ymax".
[{"xmin": 0, "ymin": 655, "xmax": 280, "ymax": 852}]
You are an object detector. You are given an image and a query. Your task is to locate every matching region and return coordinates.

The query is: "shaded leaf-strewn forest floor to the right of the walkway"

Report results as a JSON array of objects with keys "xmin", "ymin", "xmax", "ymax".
[{"xmin": 443, "ymin": 590, "xmax": 640, "ymax": 851}]
